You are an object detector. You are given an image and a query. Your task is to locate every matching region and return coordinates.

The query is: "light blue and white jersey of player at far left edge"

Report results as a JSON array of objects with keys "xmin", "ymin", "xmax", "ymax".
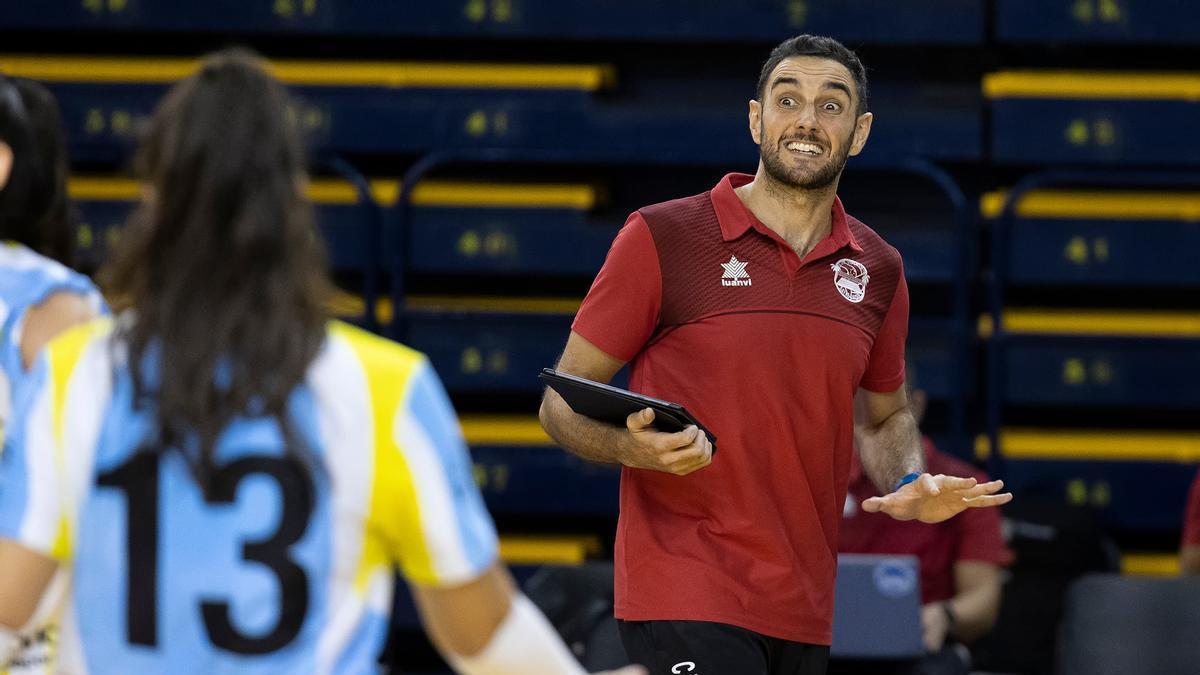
[{"xmin": 0, "ymin": 241, "xmax": 103, "ymax": 441}]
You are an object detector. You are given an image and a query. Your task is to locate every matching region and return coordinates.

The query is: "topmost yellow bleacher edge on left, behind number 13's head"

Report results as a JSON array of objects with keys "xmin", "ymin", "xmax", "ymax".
[{"xmin": 0, "ymin": 55, "xmax": 616, "ymax": 91}]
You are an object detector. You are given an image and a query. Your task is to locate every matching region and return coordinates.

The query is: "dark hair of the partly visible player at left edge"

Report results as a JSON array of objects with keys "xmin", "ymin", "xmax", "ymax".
[{"xmin": 0, "ymin": 74, "xmax": 74, "ymax": 265}]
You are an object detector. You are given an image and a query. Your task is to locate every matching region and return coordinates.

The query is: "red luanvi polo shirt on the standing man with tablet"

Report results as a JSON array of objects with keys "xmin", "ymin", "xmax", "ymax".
[{"xmin": 572, "ymin": 174, "xmax": 908, "ymax": 644}]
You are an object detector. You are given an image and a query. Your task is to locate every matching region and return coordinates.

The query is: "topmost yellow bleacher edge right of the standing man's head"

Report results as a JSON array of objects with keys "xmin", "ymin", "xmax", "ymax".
[{"xmin": 983, "ymin": 71, "xmax": 1200, "ymax": 101}]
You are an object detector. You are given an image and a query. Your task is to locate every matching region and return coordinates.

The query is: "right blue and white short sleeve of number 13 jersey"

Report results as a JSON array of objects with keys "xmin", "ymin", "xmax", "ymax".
[{"xmin": 394, "ymin": 359, "xmax": 499, "ymax": 586}]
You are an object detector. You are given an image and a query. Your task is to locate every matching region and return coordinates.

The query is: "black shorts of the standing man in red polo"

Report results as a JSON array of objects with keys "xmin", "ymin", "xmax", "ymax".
[{"xmin": 617, "ymin": 621, "xmax": 829, "ymax": 675}]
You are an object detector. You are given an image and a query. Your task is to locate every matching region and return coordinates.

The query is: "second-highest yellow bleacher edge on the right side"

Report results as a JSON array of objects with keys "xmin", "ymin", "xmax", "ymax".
[{"xmin": 979, "ymin": 190, "xmax": 1200, "ymax": 221}]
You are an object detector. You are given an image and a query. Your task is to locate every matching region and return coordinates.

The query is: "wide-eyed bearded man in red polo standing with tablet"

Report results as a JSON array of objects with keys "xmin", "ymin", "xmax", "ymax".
[{"xmin": 541, "ymin": 35, "xmax": 1010, "ymax": 675}]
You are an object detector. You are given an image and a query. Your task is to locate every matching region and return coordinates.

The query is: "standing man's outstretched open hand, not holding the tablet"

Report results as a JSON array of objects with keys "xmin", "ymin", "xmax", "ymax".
[{"xmin": 863, "ymin": 473, "xmax": 1013, "ymax": 522}]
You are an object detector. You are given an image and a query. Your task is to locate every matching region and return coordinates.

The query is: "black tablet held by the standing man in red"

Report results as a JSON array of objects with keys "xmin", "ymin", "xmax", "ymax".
[{"xmin": 538, "ymin": 368, "xmax": 716, "ymax": 454}]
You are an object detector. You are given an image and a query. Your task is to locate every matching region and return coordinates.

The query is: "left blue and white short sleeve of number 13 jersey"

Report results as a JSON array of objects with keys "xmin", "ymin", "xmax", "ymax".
[{"xmin": 0, "ymin": 352, "xmax": 64, "ymax": 556}]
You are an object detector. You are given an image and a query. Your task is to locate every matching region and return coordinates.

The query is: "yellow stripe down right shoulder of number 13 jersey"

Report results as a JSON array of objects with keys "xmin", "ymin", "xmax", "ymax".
[{"xmin": 331, "ymin": 322, "xmax": 437, "ymax": 593}]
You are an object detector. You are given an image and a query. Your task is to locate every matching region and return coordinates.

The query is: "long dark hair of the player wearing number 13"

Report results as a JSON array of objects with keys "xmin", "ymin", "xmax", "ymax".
[{"xmin": 101, "ymin": 49, "xmax": 329, "ymax": 486}]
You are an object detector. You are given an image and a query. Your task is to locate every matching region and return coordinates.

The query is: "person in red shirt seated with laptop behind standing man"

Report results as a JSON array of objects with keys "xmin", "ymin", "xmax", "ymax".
[{"xmin": 839, "ymin": 364, "xmax": 1012, "ymax": 675}]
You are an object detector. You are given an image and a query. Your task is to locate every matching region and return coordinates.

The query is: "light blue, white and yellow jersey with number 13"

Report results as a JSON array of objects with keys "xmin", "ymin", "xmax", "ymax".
[{"xmin": 0, "ymin": 321, "xmax": 498, "ymax": 674}]
